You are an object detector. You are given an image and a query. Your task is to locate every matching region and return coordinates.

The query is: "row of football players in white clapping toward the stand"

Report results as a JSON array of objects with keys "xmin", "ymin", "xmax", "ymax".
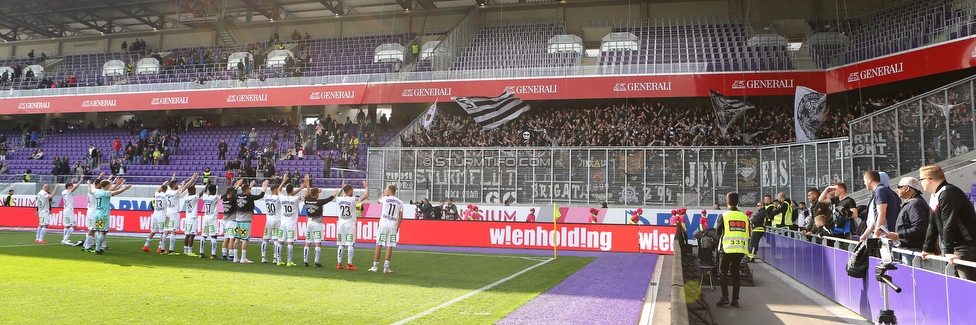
[{"xmin": 34, "ymin": 173, "xmax": 403, "ymax": 273}]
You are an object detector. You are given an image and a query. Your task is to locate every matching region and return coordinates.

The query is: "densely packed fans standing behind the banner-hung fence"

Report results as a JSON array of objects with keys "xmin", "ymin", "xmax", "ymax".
[{"xmin": 402, "ymin": 100, "xmax": 852, "ymax": 147}]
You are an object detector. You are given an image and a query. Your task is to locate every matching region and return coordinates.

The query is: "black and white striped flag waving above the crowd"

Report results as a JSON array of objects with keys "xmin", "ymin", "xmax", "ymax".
[{"xmin": 454, "ymin": 92, "xmax": 531, "ymax": 130}]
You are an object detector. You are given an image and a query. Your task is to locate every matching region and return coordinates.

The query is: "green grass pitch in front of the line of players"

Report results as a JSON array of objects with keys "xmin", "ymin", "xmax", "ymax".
[{"xmin": 0, "ymin": 229, "xmax": 592, "ymax": 324}]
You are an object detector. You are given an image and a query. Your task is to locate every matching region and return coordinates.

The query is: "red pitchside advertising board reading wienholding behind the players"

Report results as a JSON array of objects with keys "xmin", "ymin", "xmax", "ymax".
[{"xmin": 0, "ymin": 207, "xmax": 675, "ymax": 254}]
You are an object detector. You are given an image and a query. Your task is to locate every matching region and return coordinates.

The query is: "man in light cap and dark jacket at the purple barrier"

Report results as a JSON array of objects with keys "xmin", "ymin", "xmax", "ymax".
[{"xmin": 885, "ymin": 177, "xmax": 929, "ymax": 266}]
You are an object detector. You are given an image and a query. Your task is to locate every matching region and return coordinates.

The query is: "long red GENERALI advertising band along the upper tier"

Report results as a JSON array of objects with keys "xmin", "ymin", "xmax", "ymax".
[{"xmin": 0, "ymin": 37, "xmax": 976, "ymax": 114}]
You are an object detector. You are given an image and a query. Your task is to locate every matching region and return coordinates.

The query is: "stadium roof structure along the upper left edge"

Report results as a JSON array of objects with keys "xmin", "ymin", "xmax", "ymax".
[{"xmin": 0, "ymin": 0, "xmax": 510, "ymax": 41}]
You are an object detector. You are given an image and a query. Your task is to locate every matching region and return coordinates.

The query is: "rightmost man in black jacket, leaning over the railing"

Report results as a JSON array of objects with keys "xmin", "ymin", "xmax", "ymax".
[{"xmin": 918, "ymin": 165, "xmax": 976, "ymax": 280}]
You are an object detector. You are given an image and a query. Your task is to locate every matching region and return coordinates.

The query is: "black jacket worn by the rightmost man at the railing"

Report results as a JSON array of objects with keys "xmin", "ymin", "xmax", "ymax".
[{"xmin": 922, "ymin": 181, "xmax": 976, "ymax": 254}]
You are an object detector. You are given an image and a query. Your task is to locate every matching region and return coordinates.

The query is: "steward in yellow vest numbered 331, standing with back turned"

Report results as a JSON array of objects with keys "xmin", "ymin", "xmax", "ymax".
[{"xmin": 715, "ymin": 192, "xmax": 751, "ymax": 308}]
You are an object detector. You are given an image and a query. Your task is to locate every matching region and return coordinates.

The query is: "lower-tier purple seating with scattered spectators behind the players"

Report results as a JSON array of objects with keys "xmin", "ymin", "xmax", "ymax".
[{"xmin": 6, "ymin": 117, "xmax": 399, "ymax": 187}]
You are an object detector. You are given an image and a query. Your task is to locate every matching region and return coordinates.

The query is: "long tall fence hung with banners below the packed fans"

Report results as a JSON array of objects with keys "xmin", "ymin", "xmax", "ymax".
[{"xmin": 367, "ymin": 139, "xmax": 855, "ymax": 207}]
